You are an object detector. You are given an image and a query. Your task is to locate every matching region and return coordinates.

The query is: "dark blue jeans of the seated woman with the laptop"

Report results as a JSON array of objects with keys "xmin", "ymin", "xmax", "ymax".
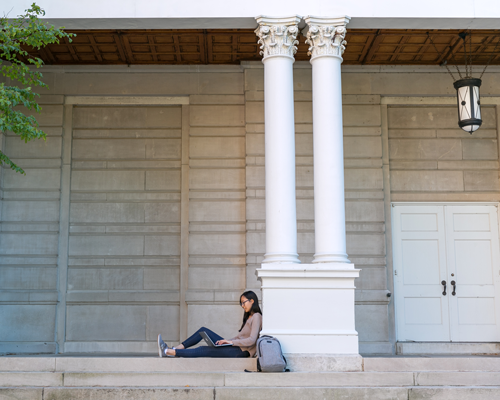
[{"xmin": 175, "ymin": 328, "xmax": 250, "ymax": 358}]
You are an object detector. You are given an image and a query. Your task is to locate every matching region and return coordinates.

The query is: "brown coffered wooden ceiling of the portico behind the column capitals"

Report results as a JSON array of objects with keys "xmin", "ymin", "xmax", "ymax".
[{"xmin": 23, "ymin": 29, "xmax": 500, "ymax": 65}]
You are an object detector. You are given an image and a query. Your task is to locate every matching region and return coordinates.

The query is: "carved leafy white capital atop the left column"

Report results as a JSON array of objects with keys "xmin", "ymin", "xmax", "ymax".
[{"xmin": 255, "ymin": 15, "xmax": 300, "ymax": 59}]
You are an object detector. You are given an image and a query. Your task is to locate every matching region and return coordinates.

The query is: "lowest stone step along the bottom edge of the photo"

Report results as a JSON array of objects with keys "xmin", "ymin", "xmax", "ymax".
[{"xmin": 0, "ymin": 386, "xmax": 500, "ymax": 400}]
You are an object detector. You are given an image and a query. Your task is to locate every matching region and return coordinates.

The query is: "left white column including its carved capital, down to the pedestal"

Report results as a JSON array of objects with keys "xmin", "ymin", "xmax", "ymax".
[{"xmin": 255, "ymin": 16, "xmax": 300, "ymax": 263}]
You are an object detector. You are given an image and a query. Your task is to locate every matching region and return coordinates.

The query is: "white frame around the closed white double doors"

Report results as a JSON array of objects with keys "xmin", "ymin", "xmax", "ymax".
[{"xmin": 391, "ymin": 201, "xmax": 500, "ymax": 343}]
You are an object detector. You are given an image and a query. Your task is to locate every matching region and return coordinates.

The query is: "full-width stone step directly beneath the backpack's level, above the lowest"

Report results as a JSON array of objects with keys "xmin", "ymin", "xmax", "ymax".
[{"xmin": 0, "ymin": 372, "xmax": 500, "ymax": 387}]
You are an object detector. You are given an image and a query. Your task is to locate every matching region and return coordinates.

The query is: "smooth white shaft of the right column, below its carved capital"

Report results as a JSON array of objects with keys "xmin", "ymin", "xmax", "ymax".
[{"xmin": 311, "ymin": 56, "xmax": 349, "ymax": 263}]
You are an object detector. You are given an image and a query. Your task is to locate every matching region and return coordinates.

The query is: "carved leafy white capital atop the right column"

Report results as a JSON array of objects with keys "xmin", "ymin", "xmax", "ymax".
[{"xmin": 304, "ymin": 16, "xmax": 350, "ymax": 60}]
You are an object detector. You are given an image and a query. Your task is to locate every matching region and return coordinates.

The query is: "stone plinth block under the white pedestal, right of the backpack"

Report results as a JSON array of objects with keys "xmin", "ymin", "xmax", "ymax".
[{"xmin": 285, "ymin": 353, "xmax": 363, "ymax": 372}]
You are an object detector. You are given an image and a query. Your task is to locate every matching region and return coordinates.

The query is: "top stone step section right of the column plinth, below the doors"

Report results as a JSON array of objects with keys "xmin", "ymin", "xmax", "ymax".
[{"xmin": 363, "ymin": 357, "xmax": 500, "ymax": 372}]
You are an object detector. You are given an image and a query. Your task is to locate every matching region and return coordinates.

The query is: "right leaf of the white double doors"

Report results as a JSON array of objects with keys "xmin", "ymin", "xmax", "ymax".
[{"xmin": 445, "ymin": 206, "xmax": 500, "ymax": 342}]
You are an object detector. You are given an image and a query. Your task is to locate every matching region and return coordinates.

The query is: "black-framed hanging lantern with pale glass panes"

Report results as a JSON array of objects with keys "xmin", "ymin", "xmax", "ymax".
[{"xmin": 453, "ymin": 78, "xmax": 483, "ymax": 135}]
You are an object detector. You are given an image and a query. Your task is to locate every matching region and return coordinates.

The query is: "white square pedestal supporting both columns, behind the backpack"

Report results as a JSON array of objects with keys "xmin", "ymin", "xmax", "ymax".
[{"xmin": 257, "ymin": 263, "xmax": 359, "ymax": 355}]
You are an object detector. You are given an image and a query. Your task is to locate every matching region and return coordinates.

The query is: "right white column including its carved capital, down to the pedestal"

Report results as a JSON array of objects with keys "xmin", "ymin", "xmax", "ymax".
[{"xmin": 305, "ymin": 16, "xmax": 349, "ymax": 263}]
